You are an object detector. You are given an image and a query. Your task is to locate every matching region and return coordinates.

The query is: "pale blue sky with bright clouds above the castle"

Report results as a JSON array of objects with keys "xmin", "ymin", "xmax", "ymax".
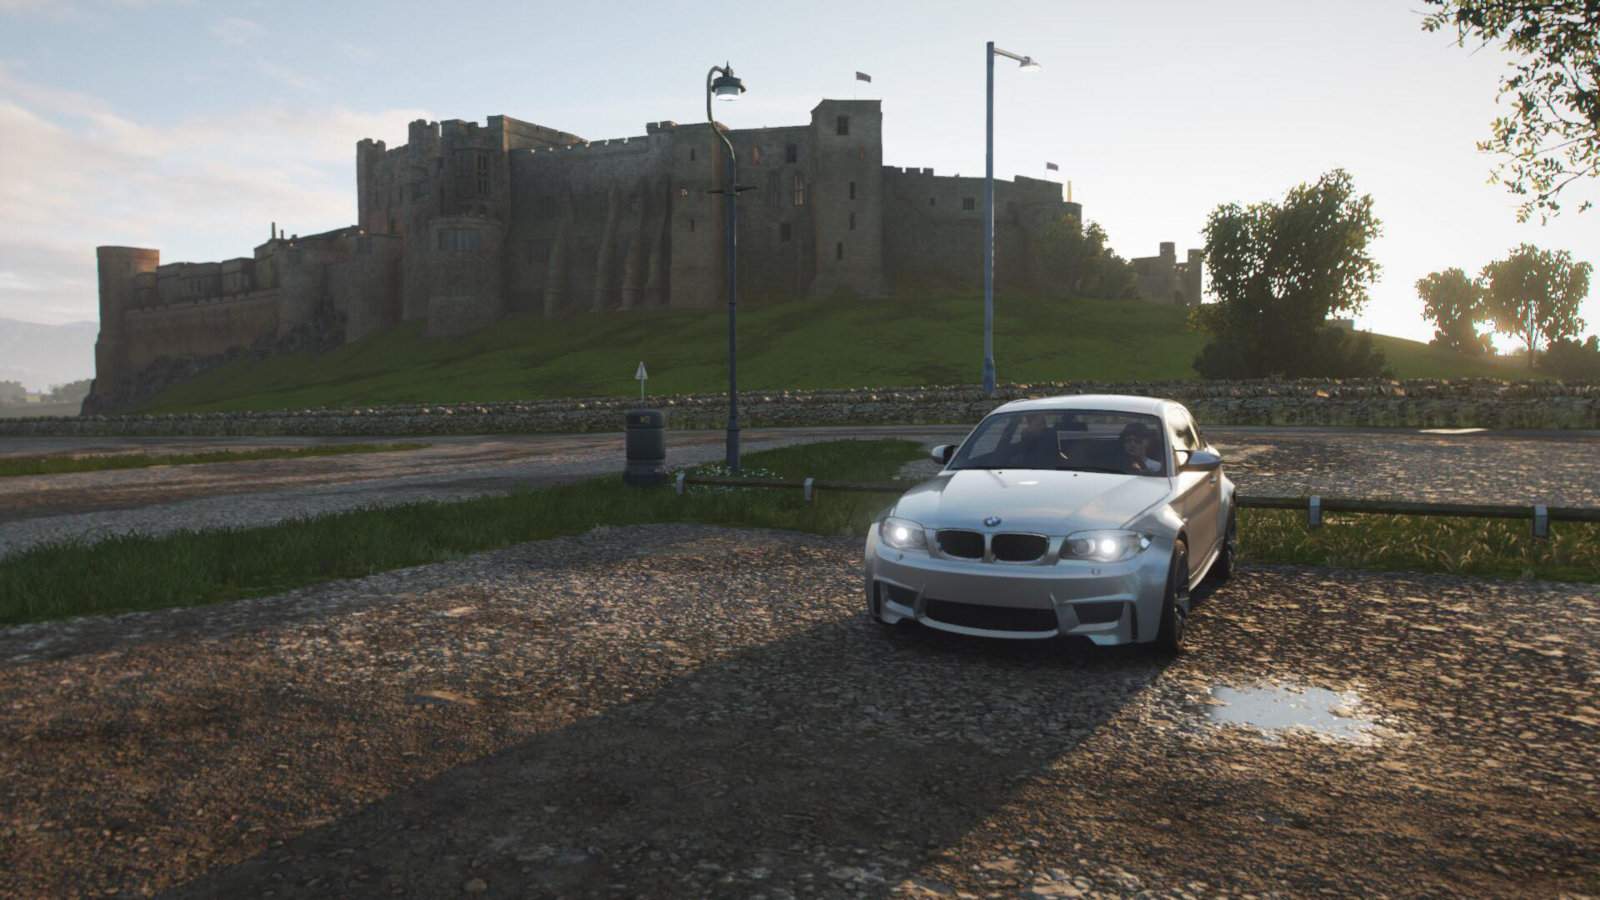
[{"xmin": 0, "ymin": 0, "xmax": 1600, "ymax": 348}]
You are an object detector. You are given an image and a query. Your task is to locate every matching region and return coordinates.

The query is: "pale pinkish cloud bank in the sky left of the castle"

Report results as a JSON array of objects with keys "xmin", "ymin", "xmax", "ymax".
[{"xmin": 0, "ymin": 64, "xmax": 427, "ymax": 322}]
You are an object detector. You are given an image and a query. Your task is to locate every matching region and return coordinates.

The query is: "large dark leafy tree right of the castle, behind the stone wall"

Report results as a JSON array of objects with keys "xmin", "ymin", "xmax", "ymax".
[{"xmin": 1194, "ymin": 170, "xmax": 1384, "ymax": 378}]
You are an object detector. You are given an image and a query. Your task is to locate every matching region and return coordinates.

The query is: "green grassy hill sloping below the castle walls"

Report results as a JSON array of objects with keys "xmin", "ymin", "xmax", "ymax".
[{"xmin": 144, "ymin": 296, "xmax": 1525, "ymax": 412}]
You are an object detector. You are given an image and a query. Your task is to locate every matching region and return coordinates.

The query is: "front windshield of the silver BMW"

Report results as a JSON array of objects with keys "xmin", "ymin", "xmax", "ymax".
[{"xmin": 949, "ymin": 410, "xmax": 1168, "ymax": 476}]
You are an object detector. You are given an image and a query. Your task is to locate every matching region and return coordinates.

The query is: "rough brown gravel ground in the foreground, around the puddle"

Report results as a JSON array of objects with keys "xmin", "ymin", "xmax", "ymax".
[{"xmin": 0, "ymin": 525, "xmax": 1600, "ymax": 898}]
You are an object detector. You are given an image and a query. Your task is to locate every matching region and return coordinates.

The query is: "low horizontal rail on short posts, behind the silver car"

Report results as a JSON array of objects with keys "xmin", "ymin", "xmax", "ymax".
[{"xmin": 674, "ymin": 472, "xmax": 1600, "ymax": 538}]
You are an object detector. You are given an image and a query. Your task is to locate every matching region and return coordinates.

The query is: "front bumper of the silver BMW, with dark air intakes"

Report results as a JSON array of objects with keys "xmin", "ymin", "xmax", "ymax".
[{"xmin": 866, "ymin": 528, "xmax": 1171, "ymax": 645}]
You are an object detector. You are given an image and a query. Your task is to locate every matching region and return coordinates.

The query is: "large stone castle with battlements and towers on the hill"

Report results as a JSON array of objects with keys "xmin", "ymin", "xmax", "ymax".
[{"xmin": 85, "ymin": 99, "xmax": 1198, "ymax": 412}]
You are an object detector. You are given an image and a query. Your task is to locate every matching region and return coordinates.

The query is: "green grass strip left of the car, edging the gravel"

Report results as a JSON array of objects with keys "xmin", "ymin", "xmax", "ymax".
[{"xmin": 0, "ymin": 440, "xmax": 922, "ymax": 625}]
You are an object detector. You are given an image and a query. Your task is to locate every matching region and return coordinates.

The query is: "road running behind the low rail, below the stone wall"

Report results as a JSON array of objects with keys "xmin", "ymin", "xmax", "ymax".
[{"xmin": 0, "ymin": 426, "xmax": 1600, "ymax": 556}]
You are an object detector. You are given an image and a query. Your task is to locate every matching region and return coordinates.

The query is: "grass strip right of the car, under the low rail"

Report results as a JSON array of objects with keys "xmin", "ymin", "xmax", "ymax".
[{"xmin": 1238, "ymin": 509, "xmax": 1600, "ymax": 583}]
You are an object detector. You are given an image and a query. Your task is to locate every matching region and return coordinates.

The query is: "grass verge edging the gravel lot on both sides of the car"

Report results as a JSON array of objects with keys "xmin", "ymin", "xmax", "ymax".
[{"xmin": 0, "ymin": 440, "xmax": 1600, "ymax": 625}]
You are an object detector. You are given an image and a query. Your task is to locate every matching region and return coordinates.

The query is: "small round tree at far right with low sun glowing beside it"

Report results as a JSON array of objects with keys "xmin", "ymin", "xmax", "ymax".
[{"xmin": 1480, "ymin": 243, "xmax": 1594, "ymax": 368}]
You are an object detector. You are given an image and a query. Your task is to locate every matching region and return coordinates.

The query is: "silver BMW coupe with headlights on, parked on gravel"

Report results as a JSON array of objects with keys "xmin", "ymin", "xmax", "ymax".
[{"xmin": 866, "ymin": 396, "xmax": 1237, "ymax": 652}]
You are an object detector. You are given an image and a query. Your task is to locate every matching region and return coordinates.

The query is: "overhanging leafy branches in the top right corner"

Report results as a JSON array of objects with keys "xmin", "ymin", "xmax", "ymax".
[{"xmin": 1422, "ymin": 0, "xmax": 1600, "ymax": 221}]
